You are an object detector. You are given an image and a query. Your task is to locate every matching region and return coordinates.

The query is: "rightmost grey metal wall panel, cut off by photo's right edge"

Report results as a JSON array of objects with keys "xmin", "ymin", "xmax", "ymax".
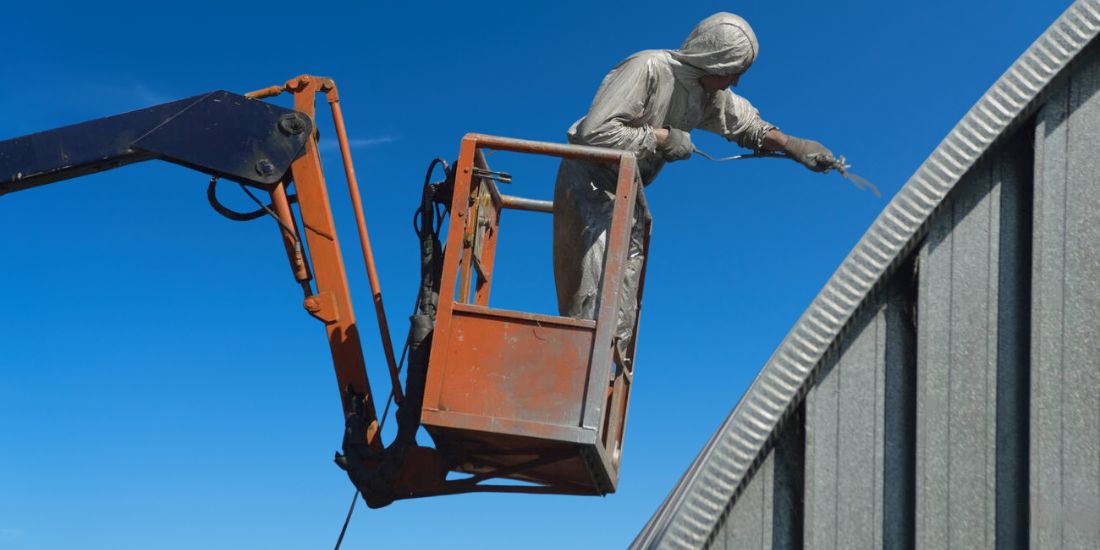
[{"xmin": 1031, "ymin": 45, "xmax": 1100, "ymax": 548}]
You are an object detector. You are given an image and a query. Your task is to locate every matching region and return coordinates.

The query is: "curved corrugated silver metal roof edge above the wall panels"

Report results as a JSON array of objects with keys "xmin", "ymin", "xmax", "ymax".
[{"xmin": 631, "ymin": 0, "xmax": 1100, "ymax": 548}]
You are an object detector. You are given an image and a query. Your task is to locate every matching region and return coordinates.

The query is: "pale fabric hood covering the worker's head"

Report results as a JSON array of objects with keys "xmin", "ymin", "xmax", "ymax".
[{"xmin": 671, "ymin": 12, "xmax": 760, "ymax": 76}]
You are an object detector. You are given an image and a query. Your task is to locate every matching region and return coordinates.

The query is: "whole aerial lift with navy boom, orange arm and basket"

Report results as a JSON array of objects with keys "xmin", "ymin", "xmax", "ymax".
[{"xmin": 0, "ymin": 75, "xmax": 650, "ymax": 507}]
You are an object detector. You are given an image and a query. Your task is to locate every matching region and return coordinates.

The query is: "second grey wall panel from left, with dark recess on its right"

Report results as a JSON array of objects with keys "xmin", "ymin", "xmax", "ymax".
[{"xmin": 803, "ymin": 270, "xmax": 915, "ymax": 549}]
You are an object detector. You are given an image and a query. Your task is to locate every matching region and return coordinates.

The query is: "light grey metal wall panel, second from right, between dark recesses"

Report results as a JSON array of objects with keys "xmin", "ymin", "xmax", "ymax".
[{"xmin": 916, "ymin": 152, "xmax": 1000, "ymax": 549}]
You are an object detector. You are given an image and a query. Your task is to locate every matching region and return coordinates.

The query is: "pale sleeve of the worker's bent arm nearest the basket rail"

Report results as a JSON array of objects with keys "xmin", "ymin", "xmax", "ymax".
[{"xmin": 574, "ymin": 57, "xmax": 660, "ymax": 156}]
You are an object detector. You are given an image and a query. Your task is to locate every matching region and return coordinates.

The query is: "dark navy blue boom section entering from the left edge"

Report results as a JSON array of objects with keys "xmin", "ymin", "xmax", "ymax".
[{"xmin": 0, "ymin": 90, "xmax": 314, "ymax": 195}]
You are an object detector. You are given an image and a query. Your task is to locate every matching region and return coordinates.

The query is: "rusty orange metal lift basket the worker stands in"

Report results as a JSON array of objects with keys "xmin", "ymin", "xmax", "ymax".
[{"xmin": 421, "ymin": 134, "xmax": 649, "ymax": 494}]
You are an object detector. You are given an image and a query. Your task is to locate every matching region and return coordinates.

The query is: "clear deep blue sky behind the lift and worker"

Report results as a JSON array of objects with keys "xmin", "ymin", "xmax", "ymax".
[{"xmin": 0, "ymin": 0, "xmax": 1070, "ymax": 549}]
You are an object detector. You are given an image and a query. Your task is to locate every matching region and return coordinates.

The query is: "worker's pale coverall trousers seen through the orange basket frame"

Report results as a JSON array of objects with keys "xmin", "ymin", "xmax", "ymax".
[{"xmin": 553, "ymin": 160, "xmax": 645, "ymax": 351}]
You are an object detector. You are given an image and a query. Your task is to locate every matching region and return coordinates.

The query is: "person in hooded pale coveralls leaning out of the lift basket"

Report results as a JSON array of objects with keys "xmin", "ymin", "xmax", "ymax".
[{"xmin": 553, "ymin": 13, "xmax": 835, "ymax": 361}]
